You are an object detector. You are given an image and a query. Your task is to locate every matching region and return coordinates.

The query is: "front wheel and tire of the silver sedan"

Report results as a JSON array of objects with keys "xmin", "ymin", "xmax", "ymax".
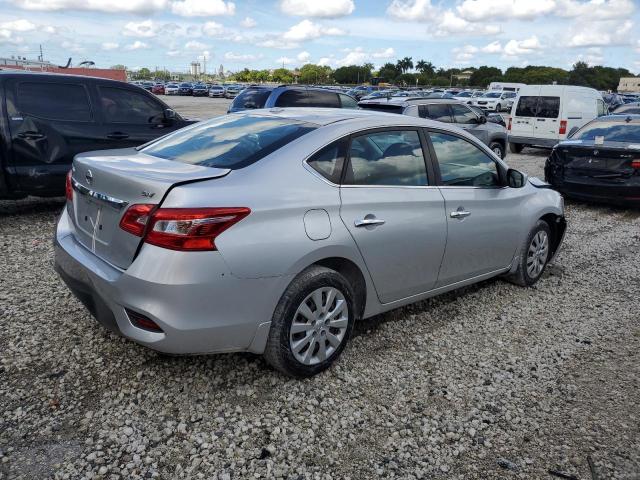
[{"xmin": 507, "ymin": 220, "xmax": 551, "ymax": 287}]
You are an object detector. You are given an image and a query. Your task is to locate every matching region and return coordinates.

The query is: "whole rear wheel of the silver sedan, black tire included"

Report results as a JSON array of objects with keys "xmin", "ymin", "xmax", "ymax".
[{"xmin": 264, "ymin": 265, "xmax": 355, "ymax": 378}]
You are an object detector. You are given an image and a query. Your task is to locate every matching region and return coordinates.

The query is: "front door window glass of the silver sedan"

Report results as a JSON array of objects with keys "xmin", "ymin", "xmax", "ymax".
[{"xmin": 429, "ymin": 132, "xmax": 501, "ymax": 187}]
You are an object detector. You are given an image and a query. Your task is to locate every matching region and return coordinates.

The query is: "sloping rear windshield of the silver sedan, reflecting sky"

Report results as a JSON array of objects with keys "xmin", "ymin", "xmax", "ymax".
[{"xmin": 141, "ymin": 115, "xmax": 317, "ymax": 170}]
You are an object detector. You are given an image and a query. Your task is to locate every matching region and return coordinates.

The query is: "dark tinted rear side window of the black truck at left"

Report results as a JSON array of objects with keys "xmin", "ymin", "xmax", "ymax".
[{"xmin": 17, "ymin": 82, "xmax": 91, "ymax": 122}]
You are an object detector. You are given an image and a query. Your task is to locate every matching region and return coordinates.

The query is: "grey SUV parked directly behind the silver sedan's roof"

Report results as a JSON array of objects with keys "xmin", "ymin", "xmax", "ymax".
[{"xmin": 358, "ymin": 98, "xmax": 507, "ymax": 158}]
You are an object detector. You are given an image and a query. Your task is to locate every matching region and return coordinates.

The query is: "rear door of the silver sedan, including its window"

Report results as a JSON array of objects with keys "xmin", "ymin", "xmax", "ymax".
[{"xmin": 340, "ymin": 128, "xmax": 447, "ymax": 303}]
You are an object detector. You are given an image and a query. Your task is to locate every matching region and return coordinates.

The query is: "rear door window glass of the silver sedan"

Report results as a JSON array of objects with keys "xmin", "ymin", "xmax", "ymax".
[{"xmin": 344, "ymin": 130, "xmax": 427, "ymax": 186}]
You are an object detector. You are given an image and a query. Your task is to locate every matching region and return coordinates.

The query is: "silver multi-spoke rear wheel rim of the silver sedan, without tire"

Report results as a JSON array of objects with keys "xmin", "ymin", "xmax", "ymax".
[{"xmin": 289, "ymin": 287, "xmax": 349, "ymax": 365}]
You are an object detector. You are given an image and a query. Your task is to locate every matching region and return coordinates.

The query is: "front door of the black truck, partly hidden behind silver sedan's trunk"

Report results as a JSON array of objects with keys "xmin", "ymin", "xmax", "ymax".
[{"xmin": 96, "ymin": 85, "xmax": 184, "ymax": 149}]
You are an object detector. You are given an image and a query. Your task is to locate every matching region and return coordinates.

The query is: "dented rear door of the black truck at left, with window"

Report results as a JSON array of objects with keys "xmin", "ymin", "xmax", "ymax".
[{"xmin": 6, "ymin": 75, "xmax": 99, "ymax": 195}]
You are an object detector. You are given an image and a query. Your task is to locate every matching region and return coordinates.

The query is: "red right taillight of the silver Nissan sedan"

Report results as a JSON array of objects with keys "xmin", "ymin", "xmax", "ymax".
[{"xmin": 120, "ymin": 204, "xmax": 251, "ymax": 251}]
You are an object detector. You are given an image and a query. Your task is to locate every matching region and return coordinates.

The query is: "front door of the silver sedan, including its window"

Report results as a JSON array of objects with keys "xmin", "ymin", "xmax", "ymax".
[{"xmin": 428, "ymin": 130, "xmax": 525, "ymax": 286}]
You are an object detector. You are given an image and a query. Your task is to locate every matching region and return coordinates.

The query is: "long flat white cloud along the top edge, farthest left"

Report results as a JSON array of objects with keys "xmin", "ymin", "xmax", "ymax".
[{"xmin": 13, "ymin": 0, "xmax": 168, "ymax": 13}]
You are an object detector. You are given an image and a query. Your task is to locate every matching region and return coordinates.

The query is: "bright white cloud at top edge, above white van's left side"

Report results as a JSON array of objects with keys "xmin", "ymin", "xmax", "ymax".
[{"xmin": 456, "ymin": 0, "xmax": 556, "ymax": 22}]
